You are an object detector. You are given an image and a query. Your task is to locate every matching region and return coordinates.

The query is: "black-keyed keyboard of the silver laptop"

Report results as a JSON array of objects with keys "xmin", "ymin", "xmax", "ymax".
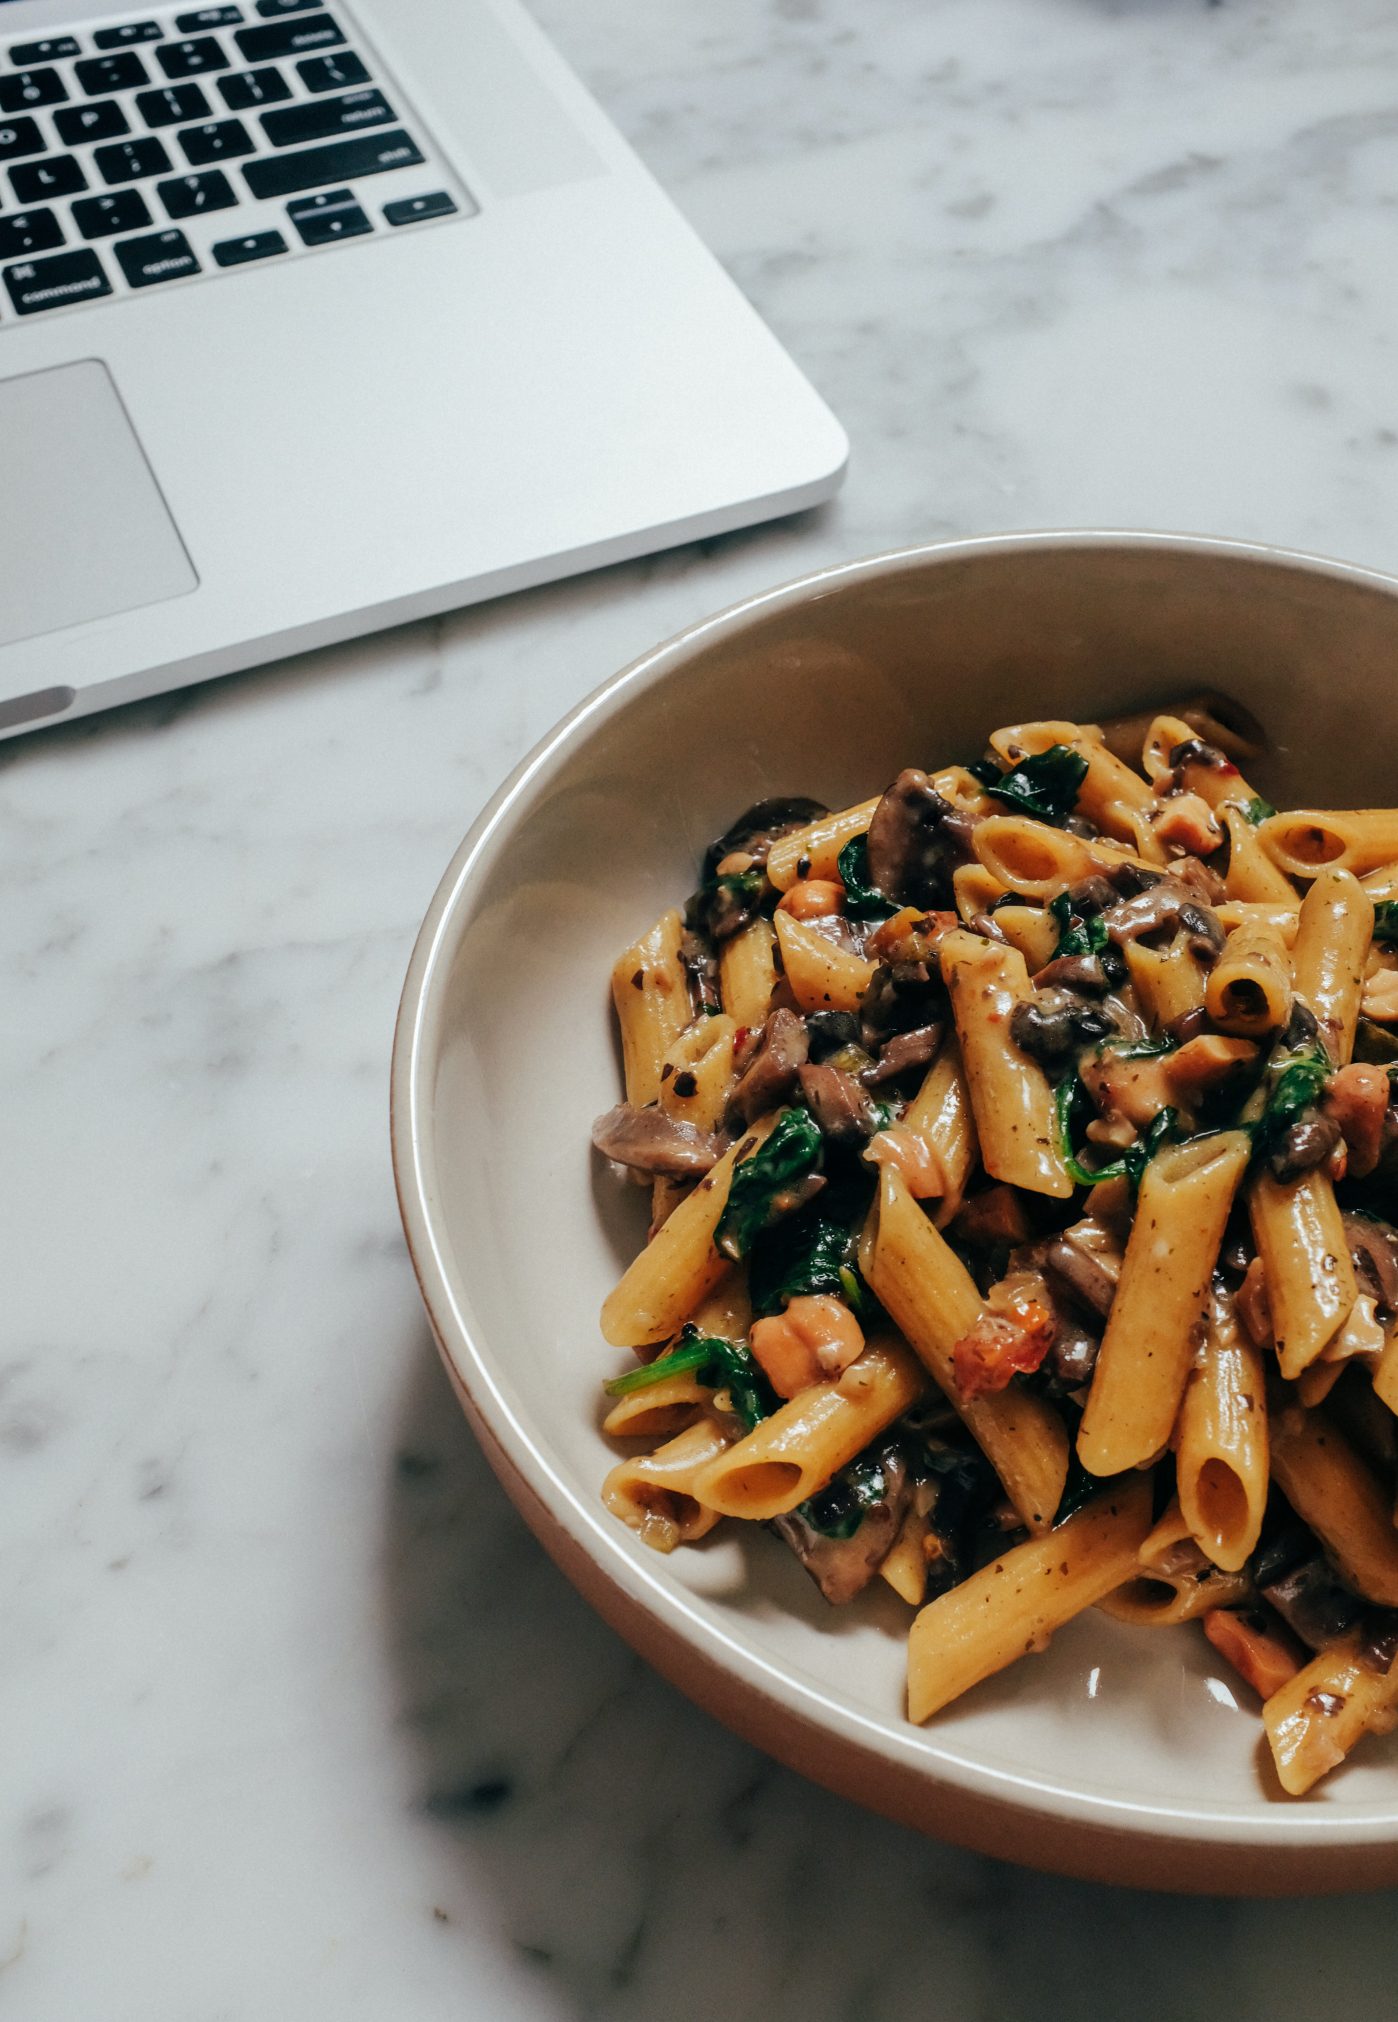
[{"xmin": 0, "ymin": 0, "xmax": 475, "ymax": 321}]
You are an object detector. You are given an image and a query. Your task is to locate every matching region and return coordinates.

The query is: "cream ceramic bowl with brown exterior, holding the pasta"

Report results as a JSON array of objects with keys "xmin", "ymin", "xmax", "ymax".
[{"xmin": 392, "ymin": 534, "xmax": 1398, "ymax": 1893}]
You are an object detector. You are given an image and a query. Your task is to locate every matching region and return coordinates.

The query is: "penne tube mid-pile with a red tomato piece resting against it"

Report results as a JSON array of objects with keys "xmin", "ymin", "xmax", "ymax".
[{"xmin": 860, "ymin": 1167, "xmax": 1068, "ymax": 1531}]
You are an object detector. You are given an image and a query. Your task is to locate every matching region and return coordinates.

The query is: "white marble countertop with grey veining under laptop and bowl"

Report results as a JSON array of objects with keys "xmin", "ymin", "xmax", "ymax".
[{"xmin": 0, "ymin": 0, "xmax": 1398, "ymax": 2022}]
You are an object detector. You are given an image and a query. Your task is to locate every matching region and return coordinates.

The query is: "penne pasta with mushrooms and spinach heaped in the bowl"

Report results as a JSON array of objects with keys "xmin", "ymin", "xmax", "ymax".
[{"xmin": 593, "ymin": 698, "xmax": 1398, "ymax": 1796}]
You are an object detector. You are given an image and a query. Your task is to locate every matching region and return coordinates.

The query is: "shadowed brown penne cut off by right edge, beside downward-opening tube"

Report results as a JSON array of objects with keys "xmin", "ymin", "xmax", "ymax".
[{"xmin": 1273, "ymin": 1405, "xmax": 1398, "ymax": 1607}]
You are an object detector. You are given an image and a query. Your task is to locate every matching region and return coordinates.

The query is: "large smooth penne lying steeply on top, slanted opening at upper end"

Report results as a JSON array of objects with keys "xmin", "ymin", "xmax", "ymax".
[{"xmin": 1078, "ymin": 1130, "xmax": 1248, "ymax": 1474}]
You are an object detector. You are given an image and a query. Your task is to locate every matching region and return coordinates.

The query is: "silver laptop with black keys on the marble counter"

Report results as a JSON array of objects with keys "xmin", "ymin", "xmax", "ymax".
[{"xmin": 0, "ymin": 0, "xmax": 848, "ymax": 736}]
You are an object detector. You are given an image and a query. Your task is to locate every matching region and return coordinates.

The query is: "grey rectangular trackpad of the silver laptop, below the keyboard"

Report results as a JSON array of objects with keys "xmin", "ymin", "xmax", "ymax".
[{"xmin": 0, "ymin": 358, "xmax": 198, "ymax": 645}]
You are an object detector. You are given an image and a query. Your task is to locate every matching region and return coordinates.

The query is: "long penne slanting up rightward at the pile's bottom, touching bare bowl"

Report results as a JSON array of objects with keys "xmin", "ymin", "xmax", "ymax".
[{"xmin": 908, "ymin": 1476, "xmax": 1151, "ymax": 1721}]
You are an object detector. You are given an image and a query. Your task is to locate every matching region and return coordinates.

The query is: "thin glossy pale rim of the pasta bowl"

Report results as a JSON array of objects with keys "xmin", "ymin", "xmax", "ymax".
[{"xmin": 390, "ymin": 528, "xmax": 1398, "ymax": 1860}]
